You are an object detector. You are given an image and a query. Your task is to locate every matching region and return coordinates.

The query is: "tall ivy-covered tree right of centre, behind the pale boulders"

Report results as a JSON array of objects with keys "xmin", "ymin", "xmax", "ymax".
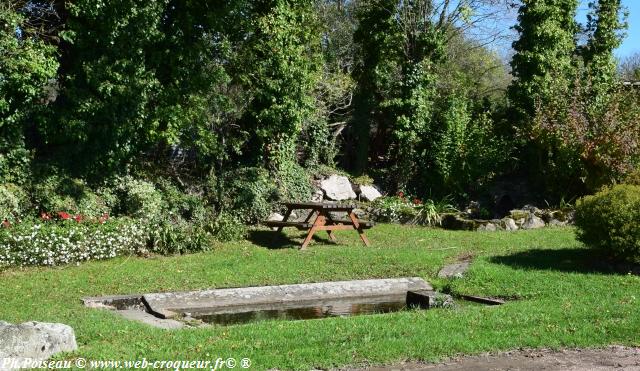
[{"xmin": 356, "ymin": 0, "xmax": 445, "ymax": 188}]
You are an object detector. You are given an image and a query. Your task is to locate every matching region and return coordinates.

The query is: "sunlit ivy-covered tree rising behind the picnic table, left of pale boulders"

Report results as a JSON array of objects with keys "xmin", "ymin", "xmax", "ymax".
[{"xmin": 242, "ymin": 0, "xmax": 321, "ymax": 173}]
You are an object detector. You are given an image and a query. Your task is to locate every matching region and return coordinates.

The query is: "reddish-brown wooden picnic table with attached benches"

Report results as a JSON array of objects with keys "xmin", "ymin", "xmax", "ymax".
[{"xmin": 262, "ymin": 202, "xmax": 374, "ymax": 250}]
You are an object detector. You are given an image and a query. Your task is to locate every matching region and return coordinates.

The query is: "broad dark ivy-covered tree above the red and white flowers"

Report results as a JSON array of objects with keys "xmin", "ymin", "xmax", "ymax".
[{"xmin": 46, "ymin": 0, "xmax": 165, "ymax": 174}]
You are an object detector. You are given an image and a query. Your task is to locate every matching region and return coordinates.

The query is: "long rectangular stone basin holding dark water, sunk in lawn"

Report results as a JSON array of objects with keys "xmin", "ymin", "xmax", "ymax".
[{"xmin": 83, "ymin": 277, "xmax": 476, "ymax": 329}]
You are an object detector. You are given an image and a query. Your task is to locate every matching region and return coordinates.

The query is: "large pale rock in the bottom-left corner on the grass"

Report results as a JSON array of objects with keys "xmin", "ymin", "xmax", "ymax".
[{"xmin": 0, "ymin": 321, "xmax": 78, "ymax": 370}]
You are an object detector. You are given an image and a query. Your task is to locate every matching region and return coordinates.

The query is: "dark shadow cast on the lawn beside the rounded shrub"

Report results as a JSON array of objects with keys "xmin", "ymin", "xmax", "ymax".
[{"xmin": 489, "ymin": 248, "xmax": 621, "ymax": 274}]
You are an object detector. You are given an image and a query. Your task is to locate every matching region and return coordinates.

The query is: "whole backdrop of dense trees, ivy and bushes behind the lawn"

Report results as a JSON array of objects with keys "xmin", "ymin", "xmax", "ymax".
[{"xmin": 0, "ymin": 0, "xmax": 640, "ymax": 264}]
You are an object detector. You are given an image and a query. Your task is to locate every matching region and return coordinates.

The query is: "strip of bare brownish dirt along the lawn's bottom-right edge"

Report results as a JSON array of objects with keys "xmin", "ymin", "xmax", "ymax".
[{"xmin": 352, "ymin": 346, "xmax": 640, "ymax": 371}]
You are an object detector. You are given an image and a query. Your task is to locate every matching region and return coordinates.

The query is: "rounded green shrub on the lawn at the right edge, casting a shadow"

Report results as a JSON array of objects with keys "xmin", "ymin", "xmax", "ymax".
[{"xmin": 575, "ymin": 184, "xmax": 640, "ymax": 262}]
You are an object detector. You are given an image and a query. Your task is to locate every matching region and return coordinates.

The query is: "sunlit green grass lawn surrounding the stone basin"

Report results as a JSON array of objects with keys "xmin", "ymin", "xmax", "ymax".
[{"xmin": 0, "ymin": 225, "xmax": 640, "ymax": 369}]
